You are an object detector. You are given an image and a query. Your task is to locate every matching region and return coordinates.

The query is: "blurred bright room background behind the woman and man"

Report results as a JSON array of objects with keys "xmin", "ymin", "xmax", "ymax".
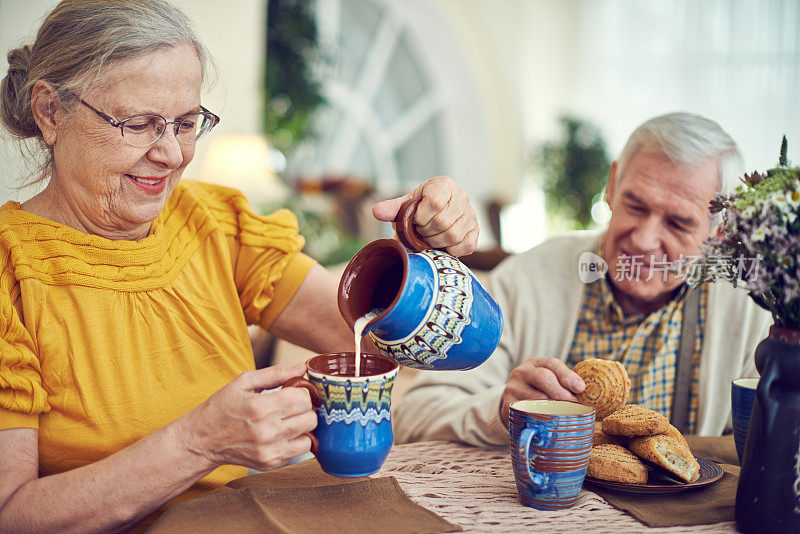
[{"xmin": 0, "ymin": 0, "xmax": 800, "ymax": 262}]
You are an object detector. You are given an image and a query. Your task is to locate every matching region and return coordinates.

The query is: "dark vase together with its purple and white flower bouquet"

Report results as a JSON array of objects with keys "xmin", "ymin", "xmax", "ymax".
[{"xmin": 701, "ymin": 137, "xmax": 800, "ymax": 533}]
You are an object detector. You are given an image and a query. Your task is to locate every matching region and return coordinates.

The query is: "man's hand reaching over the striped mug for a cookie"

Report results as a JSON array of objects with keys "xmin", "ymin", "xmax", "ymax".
[{"xmin": 500, "ymin": 358, "xmax": 586, "ymax": 427}]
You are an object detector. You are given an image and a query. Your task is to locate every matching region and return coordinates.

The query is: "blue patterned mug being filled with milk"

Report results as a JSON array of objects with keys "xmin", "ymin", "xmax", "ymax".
[{"xmin": 284, "ymin": 352, "xmax": 399, "ymax": 477}]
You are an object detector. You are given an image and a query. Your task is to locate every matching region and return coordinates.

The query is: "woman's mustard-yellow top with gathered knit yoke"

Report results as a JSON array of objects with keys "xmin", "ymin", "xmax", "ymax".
[{"xmin": 0, "ymin": 180, "xmax": 313, "ymax": 494}]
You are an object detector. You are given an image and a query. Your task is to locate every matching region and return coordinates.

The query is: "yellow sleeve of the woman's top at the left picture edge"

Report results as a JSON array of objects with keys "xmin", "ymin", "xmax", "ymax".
[{"xmin": 0, "ymin": 250, "xmax": 49, "ymax": 430}]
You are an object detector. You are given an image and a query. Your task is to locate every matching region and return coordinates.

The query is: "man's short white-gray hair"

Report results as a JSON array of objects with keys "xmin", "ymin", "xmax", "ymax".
[{"xmin": 617, "ymin": 112, "xmax": 744, "ymax": 193}]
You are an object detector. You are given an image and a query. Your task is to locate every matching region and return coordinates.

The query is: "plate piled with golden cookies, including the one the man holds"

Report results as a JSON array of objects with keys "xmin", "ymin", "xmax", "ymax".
[{"xmin": 573, "ymin": 359, "xmax": 723, "ymax": 495}]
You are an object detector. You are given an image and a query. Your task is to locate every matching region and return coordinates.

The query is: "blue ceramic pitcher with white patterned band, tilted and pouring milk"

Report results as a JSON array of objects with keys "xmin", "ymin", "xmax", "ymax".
[{"xmin": 339, "ymin": 199, "xmax": 503, "ymax": 370}]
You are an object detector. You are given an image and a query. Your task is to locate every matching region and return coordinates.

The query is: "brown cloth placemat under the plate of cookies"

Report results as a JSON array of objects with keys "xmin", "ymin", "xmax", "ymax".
[{"xmin": 590, "ymin": 436, "xmax": 739, "ymax": 527}]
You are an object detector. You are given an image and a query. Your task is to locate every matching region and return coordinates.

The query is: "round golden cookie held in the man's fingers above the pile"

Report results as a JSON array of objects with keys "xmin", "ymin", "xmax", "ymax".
[{"xmin": 572, "ymin": 358, "xmax": 631, "ymax": 421}]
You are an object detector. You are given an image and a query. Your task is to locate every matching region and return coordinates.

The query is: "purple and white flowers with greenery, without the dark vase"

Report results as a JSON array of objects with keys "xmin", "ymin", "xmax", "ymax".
[{"xmin": 692, "ymin": 137, "xmax": 800, "ymax": 329}]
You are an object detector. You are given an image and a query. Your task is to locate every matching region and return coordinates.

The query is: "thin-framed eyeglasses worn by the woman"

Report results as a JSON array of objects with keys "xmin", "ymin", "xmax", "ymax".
[{"xmin": 78, "ymin": 98, "xmax": 220, "ymax": 146}]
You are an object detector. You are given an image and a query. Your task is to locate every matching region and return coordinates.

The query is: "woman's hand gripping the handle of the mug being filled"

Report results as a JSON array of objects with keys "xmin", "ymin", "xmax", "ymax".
[{"xmin": 178, "ymin": 364, "xmax": 317, "ymax": 471}]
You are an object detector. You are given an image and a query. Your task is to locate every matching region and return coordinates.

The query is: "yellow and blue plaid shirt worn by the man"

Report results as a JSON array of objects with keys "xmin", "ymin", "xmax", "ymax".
[{"xmin": 567, "ymin": 266, "xmax": 708, "ymax": 433}]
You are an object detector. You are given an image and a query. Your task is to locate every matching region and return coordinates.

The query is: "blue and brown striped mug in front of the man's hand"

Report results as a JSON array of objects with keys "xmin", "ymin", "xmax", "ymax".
[{"xmin": 508, "ymin": 400, "xmax": 595, "ymax": 510}]
